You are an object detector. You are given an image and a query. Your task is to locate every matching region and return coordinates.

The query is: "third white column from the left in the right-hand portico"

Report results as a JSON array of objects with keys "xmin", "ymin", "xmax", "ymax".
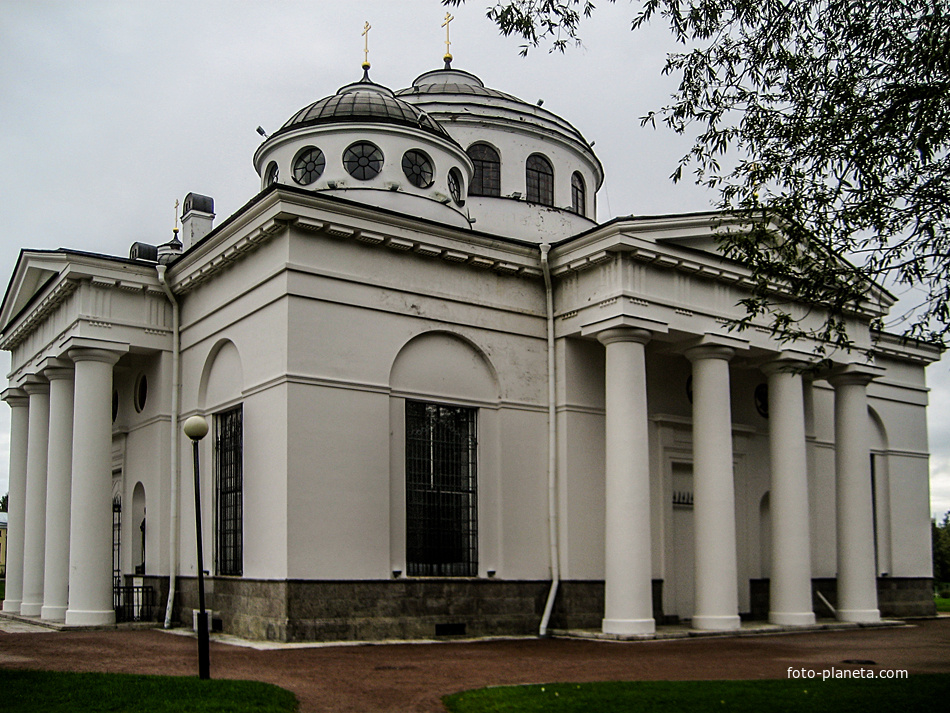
[{"xmin": 762, "ymin": 360, "xmax": 815, "ymax": 626}]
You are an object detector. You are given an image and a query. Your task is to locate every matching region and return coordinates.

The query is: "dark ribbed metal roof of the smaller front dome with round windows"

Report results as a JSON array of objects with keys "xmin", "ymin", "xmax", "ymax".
[{"xmin": 275, "ymin": 76, "xmax": 454, "ymax": 143}]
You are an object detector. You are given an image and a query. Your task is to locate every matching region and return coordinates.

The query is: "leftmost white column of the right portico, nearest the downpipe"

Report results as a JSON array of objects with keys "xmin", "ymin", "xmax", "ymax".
[{"xmin": 597, "ymin": 329, "xmax": 656, "ymax": 634}]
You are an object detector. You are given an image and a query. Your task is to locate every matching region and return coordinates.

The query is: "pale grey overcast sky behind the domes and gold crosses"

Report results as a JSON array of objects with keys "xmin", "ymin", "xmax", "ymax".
[{"xmin": 0, "ymin": 0, "xmax": 950, "ymax": 516}]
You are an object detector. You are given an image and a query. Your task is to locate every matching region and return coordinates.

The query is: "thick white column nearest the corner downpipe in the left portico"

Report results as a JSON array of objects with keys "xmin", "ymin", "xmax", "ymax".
[{"xmin": 66, "ymin": 349, "xmax": 119, "ymax": 626}]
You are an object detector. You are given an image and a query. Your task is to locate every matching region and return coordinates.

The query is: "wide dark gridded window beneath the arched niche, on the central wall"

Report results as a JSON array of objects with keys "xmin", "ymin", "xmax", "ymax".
[{"xmin": 406, "ymin": 401, "xmax": 478, "ymax": 577}]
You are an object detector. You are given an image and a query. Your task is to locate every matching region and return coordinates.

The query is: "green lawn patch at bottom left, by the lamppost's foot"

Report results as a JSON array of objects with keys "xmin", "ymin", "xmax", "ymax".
[{"xmin": 0, "ymin": 670, "xmax": 297, "ymax": 713}]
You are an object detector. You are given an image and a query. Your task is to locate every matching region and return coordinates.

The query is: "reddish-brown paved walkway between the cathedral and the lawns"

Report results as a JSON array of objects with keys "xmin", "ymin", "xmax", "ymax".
[{"xmin": 0, "ymin": 617, "xmax": 950, "ymax": 713}]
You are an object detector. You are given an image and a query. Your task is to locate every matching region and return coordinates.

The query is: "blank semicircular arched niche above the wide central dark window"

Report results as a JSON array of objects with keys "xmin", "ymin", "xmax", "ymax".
[{"xmin": 389, "ymin": 332, "xmax": 499, "ymax": 403}]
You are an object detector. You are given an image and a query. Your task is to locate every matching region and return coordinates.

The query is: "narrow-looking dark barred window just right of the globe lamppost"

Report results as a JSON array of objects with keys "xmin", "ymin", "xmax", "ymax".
[{"xmin": 214, "ymin": 406, "xmax": 244, "ymax": 576}]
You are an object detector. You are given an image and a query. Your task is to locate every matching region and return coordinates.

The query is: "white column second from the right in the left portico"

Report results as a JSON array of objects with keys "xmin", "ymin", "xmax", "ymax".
[{"xmin": 40, "ymin": 364, "xmax": 73, "ymax": 621}]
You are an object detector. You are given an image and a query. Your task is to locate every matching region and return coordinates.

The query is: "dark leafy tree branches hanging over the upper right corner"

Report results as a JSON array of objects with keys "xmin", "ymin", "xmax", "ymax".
[{"xmin": 452, "ymin": 0, "xmax": 950, "ymax": 348}]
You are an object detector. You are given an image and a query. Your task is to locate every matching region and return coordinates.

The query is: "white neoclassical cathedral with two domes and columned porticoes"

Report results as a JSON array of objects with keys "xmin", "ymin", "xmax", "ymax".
[{"xmin": 0, "ymin": 51, "xmax": 940, "ymax": 641}]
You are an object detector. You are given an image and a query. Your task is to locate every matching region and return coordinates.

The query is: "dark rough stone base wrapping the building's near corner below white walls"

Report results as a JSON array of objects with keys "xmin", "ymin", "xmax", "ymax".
[{"xmin": 169, "ymin": 577, "xmax": 662, "ymax": 641}]
